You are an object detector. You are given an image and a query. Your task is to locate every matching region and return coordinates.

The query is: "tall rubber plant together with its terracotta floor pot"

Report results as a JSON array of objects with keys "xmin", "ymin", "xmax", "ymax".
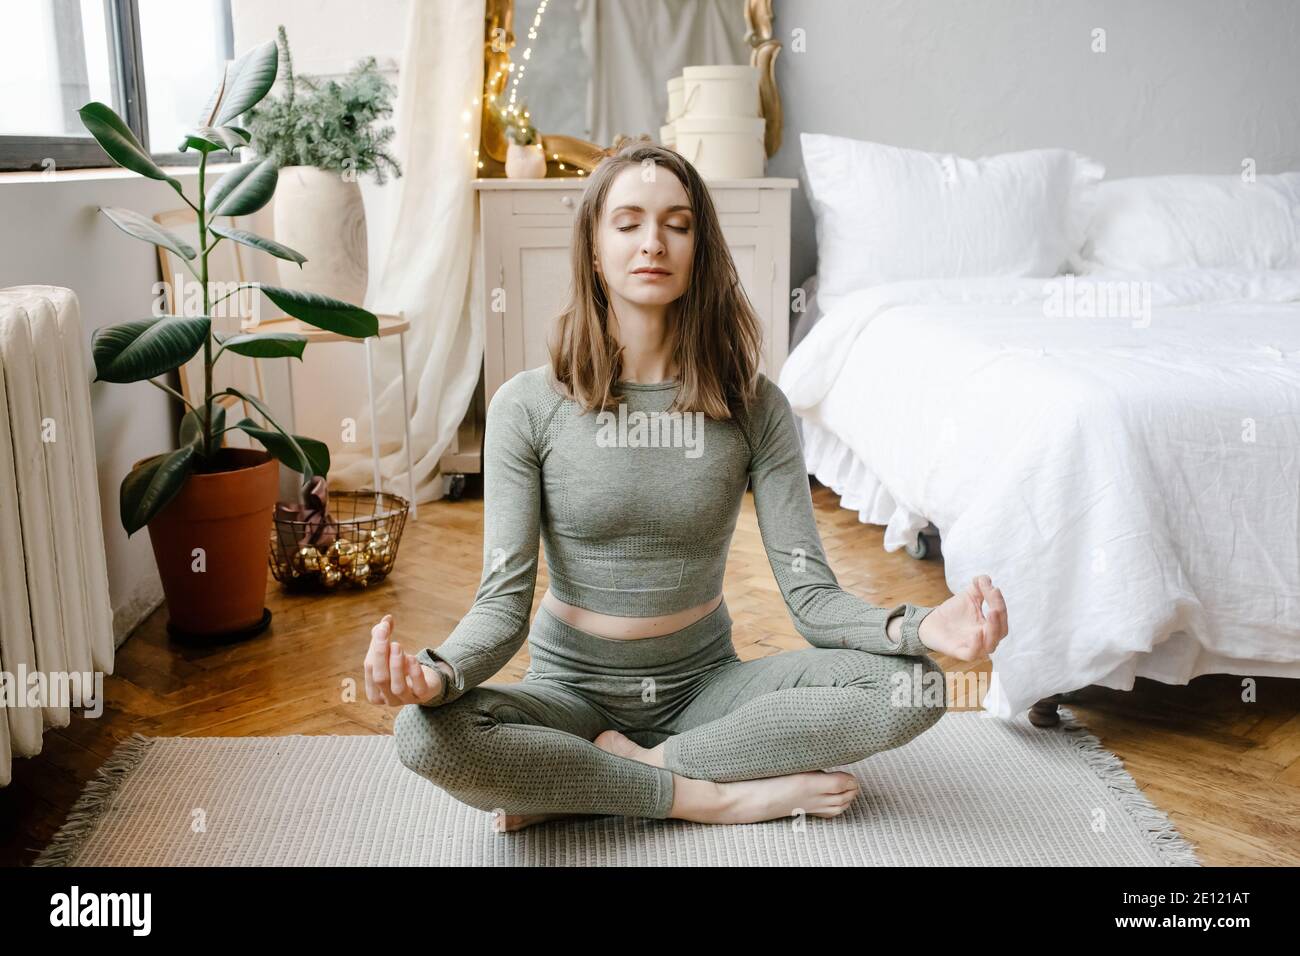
[{"xmin": 79, "ymin": 42, "xmax": 378, "ymax": 640}]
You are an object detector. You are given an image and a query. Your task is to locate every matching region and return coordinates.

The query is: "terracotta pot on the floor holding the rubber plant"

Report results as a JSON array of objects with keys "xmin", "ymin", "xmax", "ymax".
[{"xmin": 148, "ymin": 449, "xmax": 280, "ymax": 639}]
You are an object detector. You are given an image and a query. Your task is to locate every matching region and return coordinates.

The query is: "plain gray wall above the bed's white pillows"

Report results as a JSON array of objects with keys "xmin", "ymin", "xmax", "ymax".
[{"xmin": 767, "ymin": 0, "xmax": 1300, "ymax": 285}]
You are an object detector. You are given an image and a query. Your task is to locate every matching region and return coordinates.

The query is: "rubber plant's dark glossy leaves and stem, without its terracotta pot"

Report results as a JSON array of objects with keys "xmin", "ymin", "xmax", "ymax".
[{"xmin": 78, "ymin": 40, "xmax": 378, "ymax": 535}]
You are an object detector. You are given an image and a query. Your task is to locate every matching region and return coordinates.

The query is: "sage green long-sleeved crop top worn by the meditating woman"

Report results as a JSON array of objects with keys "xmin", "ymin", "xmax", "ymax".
[{"xmin": 416, "ymin": 364, "xmax": 933, "ymax": 706}]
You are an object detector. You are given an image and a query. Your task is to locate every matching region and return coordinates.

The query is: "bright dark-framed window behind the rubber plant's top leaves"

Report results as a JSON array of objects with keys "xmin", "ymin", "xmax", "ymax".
[{"xmin": 0, "ymin": 0, "xmax": 234, "ymax": 170}]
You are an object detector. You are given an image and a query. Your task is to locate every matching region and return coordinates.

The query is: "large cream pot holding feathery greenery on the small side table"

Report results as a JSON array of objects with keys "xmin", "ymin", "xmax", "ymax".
[{"xmin": 274, "ymin": 166, "xmax": 369, "ymax": 306}]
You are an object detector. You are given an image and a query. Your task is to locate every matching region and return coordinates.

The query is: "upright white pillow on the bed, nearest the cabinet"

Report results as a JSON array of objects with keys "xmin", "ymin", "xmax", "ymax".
[{"xmin": 800, "ymin": 133, "xmax": 1105, "ymax": 308}]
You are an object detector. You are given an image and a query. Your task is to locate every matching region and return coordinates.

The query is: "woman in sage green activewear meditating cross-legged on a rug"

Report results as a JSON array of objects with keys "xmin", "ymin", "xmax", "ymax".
[{"xmin": 365, "ymin": 142, "xmax": 1008, "ymax": 829}]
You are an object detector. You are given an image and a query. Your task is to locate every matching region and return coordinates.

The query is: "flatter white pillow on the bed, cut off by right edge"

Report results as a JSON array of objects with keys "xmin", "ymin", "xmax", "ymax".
[{"xmin": 1076, "ymin": 173, "xmax": 1300, "ymax": 272}]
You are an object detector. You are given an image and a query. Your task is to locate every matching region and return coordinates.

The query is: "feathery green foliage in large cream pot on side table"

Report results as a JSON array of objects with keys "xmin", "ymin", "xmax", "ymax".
[{"xmin": 248, "ymin": 26, "xmax": 402, "ymax": 302}]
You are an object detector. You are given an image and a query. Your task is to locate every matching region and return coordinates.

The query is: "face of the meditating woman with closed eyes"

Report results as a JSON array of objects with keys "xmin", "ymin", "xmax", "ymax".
[{"xmin": 595, "ymin": 163, "xmax": 696, "ymax": 308}]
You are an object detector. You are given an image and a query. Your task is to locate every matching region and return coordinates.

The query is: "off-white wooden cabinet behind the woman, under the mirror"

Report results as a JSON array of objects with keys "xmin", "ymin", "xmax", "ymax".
[{"xmin": 442, "ymin": 178, "xmax": 798, "ymax": 472}]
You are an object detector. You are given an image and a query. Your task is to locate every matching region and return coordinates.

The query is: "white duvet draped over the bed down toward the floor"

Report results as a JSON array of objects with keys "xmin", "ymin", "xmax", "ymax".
[{"xmin": 780, "ymin": 272, "xmax": 1300, "ymax": 718}]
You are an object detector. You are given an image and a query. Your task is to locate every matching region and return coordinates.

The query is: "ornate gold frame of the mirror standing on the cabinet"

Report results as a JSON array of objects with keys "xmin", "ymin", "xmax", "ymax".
[{"xmin": 478, "ymin": 0, "xmax": 781, "ymax": 178}]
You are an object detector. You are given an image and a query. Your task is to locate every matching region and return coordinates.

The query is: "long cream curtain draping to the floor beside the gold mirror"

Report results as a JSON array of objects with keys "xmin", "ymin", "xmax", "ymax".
[{"xmin": 330, "ymin": 0, "xmax": 485, "ymax": 501}]
